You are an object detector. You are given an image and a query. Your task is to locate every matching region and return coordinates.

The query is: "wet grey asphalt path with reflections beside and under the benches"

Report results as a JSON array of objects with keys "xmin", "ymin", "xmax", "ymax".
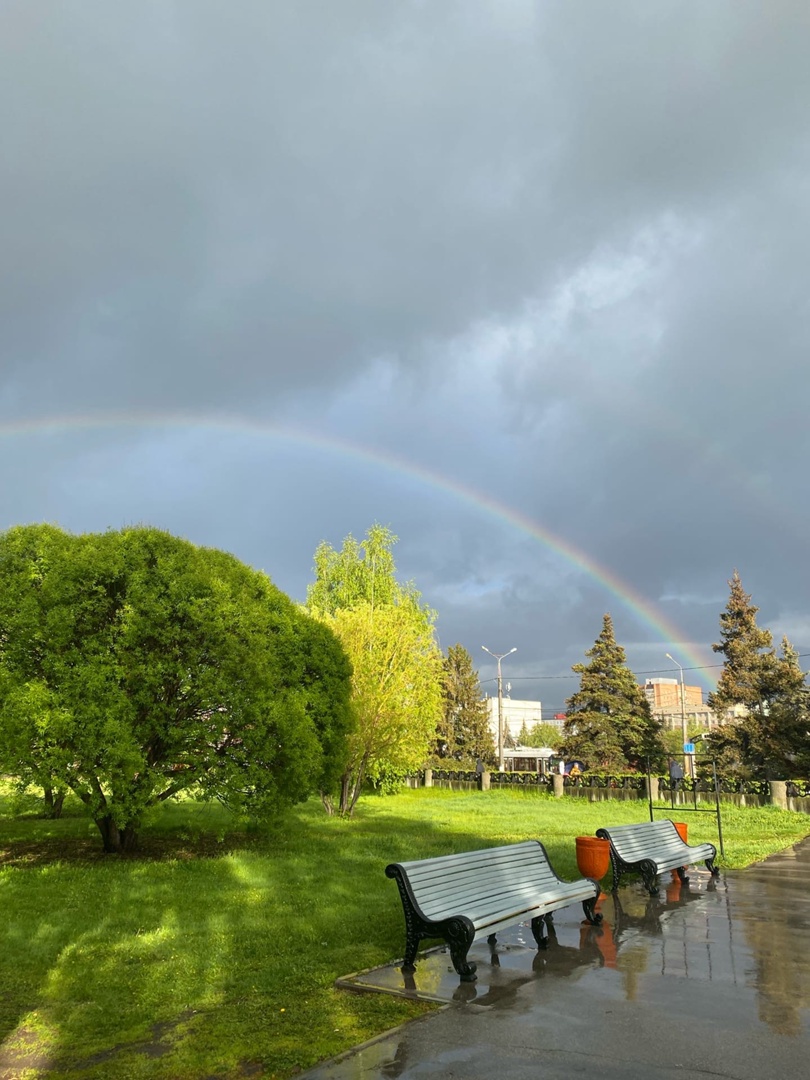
[{"xmin": 305, "ymin": 839, "xmax": 810, "ymax": 1080}]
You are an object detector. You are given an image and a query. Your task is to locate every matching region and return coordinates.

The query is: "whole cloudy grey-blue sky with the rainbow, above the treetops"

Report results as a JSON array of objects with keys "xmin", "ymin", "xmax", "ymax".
[{"xmin": 0, "ymin": 0, "xmax": 810, "ymax": 711}]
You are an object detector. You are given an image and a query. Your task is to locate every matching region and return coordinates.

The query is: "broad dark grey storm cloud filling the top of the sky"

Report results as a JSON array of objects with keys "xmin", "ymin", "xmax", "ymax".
[{"xmin": 11, "ymin": 3, "xmax": 805, "ymax": 412}]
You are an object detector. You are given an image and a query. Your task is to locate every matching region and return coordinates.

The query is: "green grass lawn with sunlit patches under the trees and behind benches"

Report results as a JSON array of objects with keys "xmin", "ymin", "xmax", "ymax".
[{"xmin": 0, "ymin": 789, "xmax": 810, "ymax": 1080}]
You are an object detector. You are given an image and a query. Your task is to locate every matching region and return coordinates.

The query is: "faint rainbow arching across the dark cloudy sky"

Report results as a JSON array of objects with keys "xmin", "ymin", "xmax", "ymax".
[{"xmin": 0, "ymin": 413, "xmax": 714, "ymax": 677}]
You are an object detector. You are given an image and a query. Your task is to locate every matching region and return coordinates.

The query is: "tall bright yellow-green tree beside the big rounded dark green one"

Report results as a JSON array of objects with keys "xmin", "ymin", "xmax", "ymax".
[{"xmin": 307, "ymin": 525, "xmax": 442, "ymax": 815}]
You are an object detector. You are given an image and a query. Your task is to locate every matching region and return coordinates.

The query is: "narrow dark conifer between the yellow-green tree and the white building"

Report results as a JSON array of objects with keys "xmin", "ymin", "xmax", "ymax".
[{"xmin": 436, "ymin": 645, "xmax": 496, "ymax": 766}]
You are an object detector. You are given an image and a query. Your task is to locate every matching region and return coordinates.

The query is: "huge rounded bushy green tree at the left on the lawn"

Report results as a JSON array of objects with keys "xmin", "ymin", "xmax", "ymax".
[{"xmin": 0, "ymin": 526, "xmax": 352, "ymax": 851}]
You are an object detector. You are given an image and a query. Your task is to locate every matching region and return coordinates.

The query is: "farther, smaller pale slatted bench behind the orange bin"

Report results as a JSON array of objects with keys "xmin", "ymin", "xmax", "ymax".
[{"xmin": 596, "ymin": 818, "xmax": 719, "ymax": 896}]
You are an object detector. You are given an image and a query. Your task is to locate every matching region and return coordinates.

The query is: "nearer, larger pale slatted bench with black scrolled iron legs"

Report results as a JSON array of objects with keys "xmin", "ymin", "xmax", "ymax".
[{"xmin": 386, "ymin": 840, "xmax": 602, "ymax": 982}]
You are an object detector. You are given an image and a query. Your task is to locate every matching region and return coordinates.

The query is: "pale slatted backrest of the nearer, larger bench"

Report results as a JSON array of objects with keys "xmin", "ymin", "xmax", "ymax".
[{"xmin": 396, "ymin": 840, "xmax": 559, "ymax": 920}]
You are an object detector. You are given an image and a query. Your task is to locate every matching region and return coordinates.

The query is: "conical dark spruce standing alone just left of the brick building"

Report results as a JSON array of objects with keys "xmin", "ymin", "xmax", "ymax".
[{"xmin": 564, "ymin": 615, "xmax": 661, "ymax": 771}]
